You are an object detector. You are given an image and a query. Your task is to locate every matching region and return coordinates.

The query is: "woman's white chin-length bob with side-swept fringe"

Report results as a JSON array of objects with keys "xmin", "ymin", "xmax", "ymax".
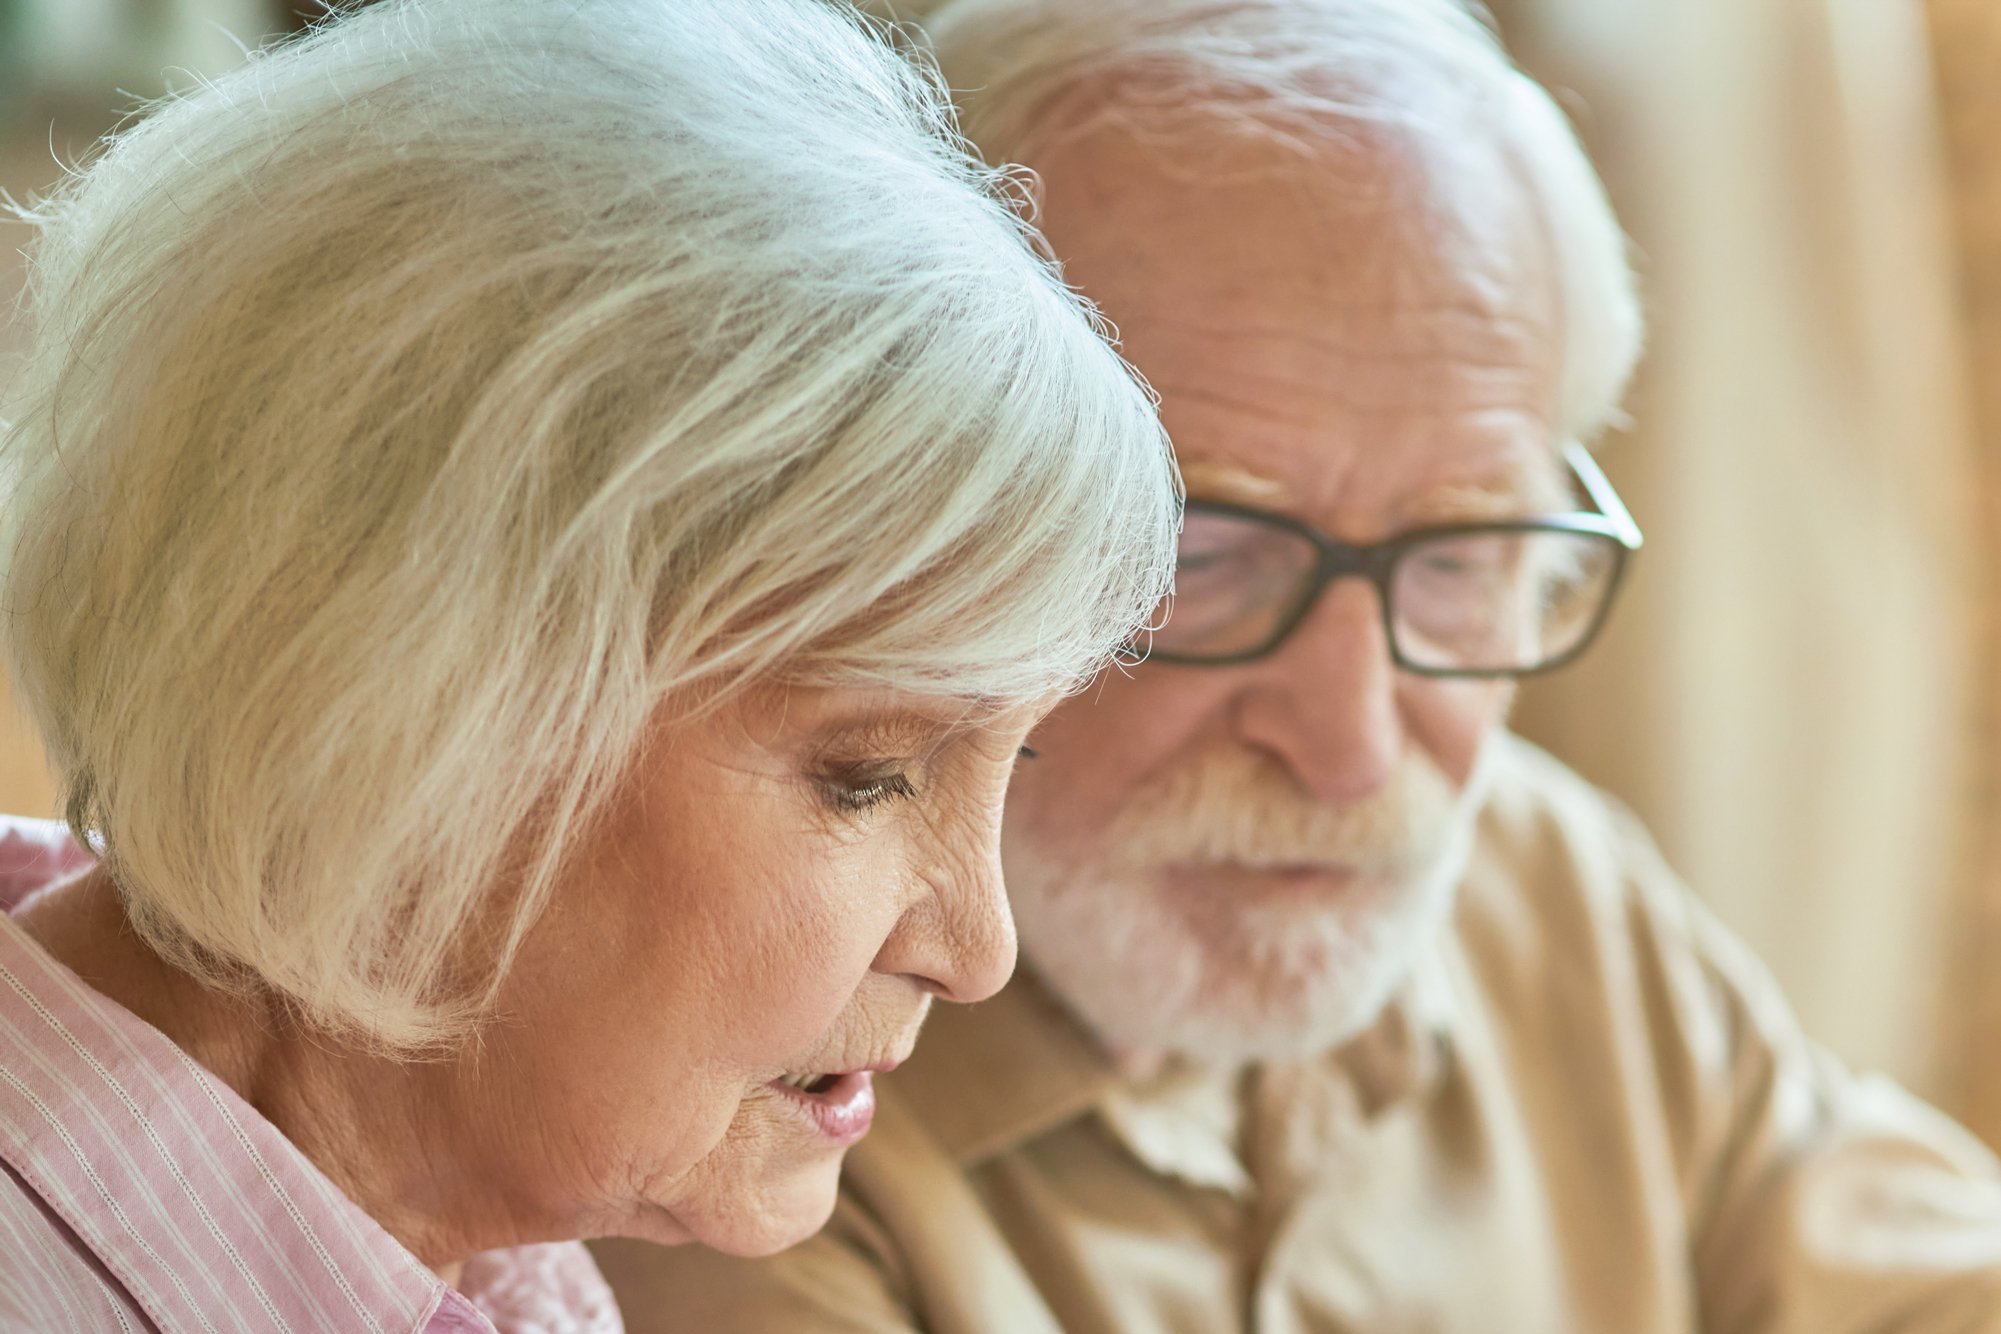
[{"xmin": 0, "ymin": 0, "xmax": 1177, "ymax": 1050}]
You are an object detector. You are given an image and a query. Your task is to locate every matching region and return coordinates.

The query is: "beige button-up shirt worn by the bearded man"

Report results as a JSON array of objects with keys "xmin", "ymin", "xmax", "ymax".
[{"xmin": 598, "ymin": 742, "xmax": 2001, "ymax": 1334}]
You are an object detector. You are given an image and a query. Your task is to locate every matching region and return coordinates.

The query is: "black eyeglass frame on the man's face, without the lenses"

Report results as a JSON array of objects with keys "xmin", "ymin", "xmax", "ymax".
[{"xmin": 1147, "ymin": 440, "xmax": 1645, "ymax": 680}]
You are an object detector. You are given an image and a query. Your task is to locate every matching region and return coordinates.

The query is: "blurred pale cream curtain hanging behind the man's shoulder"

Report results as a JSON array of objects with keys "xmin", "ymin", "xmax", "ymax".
[{"xmin": 1497, "ymin": 0, "xmax": 1979, "ymax": 1100}]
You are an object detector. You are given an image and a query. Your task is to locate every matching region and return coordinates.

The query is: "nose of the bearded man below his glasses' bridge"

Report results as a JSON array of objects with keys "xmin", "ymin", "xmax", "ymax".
[{"xmin": 1235, "ymin": 578, "xmax": 1405, "ymax": 804}]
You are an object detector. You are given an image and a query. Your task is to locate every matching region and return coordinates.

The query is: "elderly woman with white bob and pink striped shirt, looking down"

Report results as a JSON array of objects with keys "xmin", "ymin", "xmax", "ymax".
[{"xmin": 0, "ymin": 0, "xmax": 1175, "ymax": 1330}]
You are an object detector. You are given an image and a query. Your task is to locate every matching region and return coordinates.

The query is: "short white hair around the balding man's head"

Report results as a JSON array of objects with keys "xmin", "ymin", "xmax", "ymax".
[{"xmin": 866, "ymin": 0, "xmax": 1641, "ymax": 442}]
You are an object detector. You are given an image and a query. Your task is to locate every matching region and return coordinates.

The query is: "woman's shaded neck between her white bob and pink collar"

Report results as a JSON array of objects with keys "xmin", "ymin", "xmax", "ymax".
[{"xmin": 14, "ymin": 868, "xmax": 504, "ymax": 1282}]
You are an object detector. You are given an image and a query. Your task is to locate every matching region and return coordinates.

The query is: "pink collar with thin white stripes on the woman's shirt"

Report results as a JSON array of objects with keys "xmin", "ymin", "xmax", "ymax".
[{"xmin": 0, "ymin": 914, "xmax": 468, "ymax": 1334}]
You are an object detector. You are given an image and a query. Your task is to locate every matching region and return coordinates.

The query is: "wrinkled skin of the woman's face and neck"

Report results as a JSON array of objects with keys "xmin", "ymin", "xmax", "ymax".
[{"xmin": 24, "ymin": 688, "xmax": 1045, "ymax": 1276}]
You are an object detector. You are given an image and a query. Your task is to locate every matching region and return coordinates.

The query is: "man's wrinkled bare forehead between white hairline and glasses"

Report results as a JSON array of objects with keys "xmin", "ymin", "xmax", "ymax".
[{"xmin": 1033, "ymin": 111, "xmax": 1569, "ymax": 540}]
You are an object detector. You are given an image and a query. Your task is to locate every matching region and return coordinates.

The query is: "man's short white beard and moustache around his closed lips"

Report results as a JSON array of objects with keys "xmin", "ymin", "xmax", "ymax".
[{"xmin": 1003, "ymin": 752, "xmax": 1485, "ymax": 1064}]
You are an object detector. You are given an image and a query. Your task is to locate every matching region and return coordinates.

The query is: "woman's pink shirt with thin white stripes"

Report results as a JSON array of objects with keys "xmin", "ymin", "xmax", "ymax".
[{"xmin": 0, "ymin": 816, "xmax": 622, "ymax": 1334}]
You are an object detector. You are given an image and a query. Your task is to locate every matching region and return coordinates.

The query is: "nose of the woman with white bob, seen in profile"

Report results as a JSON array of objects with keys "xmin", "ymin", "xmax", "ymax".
[{"xmin": 874, "ymin": 852, "xmax": 1015, "ymax": 1004}]
